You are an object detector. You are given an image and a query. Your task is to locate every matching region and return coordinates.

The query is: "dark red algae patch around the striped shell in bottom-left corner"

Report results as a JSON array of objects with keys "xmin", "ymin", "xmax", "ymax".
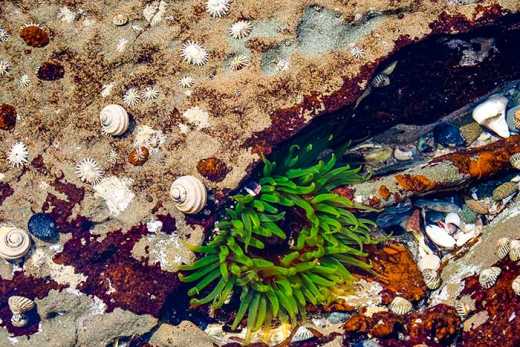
[{"xmin": 0, "ymin": 272, "xmax": 65, "ymax": 336}]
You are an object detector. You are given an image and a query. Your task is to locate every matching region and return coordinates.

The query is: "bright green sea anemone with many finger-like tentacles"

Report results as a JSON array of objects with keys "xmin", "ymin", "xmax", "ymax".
[{"xmin": 180, "ymin": 146, "xmax": 377, "ymax": 333}]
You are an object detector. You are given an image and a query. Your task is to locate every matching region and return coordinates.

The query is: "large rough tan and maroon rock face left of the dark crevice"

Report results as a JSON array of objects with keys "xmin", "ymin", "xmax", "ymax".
[{"xmin": 0, "ymin": 0, "xmax": 520, "ymax": 346}]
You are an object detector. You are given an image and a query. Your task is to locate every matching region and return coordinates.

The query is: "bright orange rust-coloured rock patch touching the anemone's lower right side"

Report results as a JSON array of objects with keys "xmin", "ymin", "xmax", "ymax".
[{"xmin": 363, "ymin": 242, "xmax": 426, "ymax": 301}]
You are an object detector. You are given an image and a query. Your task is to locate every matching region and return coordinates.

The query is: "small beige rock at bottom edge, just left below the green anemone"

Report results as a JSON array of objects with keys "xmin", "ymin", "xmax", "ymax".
[{"xmin": 150, "ymin": 321, "xmax": 214, "ymax": 347}]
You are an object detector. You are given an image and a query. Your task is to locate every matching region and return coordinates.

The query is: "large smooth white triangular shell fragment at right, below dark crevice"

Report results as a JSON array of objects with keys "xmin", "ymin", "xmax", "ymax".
[{"xmin": 473, "ymin": 95, "xmax": 510, "ymax": 138}]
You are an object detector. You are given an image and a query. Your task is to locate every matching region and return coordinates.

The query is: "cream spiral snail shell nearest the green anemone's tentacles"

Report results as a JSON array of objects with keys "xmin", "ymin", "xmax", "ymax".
[{"xmin": 170, "ymin": 176, "xmax": 208, "ymax": 214}]
